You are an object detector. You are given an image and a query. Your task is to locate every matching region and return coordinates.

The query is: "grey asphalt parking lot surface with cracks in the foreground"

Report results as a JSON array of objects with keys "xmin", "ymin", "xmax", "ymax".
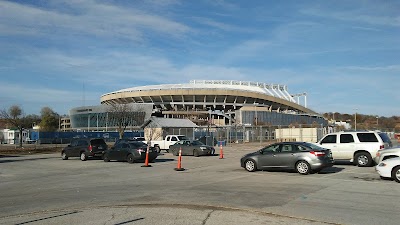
[{"xmin": 0, "ymin": 144, "xmax": 400, "ymax": 224}]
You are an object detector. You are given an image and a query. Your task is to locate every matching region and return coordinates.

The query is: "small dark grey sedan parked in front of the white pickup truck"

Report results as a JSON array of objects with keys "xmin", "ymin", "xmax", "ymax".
[{"xmin": 169, "ymin": 140, "xmax": 215, "ymax": 157}]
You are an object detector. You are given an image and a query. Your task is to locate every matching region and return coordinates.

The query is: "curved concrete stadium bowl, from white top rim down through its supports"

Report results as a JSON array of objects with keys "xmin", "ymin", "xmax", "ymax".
[{"xmin": 101, "ymin": 80, "xmax": 324, "ymax": 126}]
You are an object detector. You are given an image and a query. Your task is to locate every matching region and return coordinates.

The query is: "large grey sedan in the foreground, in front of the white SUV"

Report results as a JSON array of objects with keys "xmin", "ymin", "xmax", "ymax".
[{"xmin": 240, "ymin": 142, "xmax": 333, "ymax": 175}]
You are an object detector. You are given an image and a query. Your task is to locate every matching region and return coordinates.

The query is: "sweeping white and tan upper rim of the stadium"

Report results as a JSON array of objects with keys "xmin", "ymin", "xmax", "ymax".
[{"xmin": 101, "ymin": 80, "xmax": 317, "ymax": 115}]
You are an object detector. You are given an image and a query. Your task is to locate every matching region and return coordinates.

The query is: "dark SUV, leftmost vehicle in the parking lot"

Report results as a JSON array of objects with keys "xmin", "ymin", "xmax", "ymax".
[{"xmin": 61, "ymin": 138, "xmax": 108, "ymax": 161}]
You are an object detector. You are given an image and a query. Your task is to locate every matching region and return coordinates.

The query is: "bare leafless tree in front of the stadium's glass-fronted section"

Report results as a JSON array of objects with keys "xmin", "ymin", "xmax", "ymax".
[{"xmin": 107, "ymin": 103, "xmax": 146, "ymax": 139}]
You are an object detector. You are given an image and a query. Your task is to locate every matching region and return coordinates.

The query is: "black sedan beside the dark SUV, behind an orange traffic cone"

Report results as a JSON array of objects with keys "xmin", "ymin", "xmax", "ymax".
[{"xmin": 103, "ymin": 141, "xmax": 158, "ymax": 163}]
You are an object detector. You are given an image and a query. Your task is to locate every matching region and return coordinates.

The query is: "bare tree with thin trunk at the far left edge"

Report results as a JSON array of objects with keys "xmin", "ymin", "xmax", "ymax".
[{"xmin": 0, "ymin": 105, "xmax": 31, "ymax": 147}]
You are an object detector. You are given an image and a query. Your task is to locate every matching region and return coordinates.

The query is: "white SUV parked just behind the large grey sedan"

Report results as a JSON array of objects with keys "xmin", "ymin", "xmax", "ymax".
[{"xmin": 317, "ymin": 131, "xmax": 392, "ymax": 166}]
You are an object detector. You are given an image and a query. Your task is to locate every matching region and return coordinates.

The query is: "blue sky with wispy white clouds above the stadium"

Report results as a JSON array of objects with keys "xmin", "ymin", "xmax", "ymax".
[{"xmin": 0, "ymin": 0, "xmax": 400, "ymax": 116}]
